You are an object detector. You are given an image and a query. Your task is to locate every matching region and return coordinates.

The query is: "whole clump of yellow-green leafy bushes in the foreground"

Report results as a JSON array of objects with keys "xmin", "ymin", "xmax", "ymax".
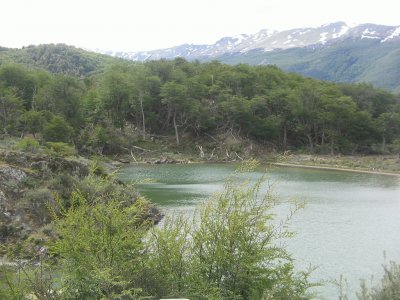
[{"xmin": 0, "ymin": 163, "xmax": 312, "ymax": 299}]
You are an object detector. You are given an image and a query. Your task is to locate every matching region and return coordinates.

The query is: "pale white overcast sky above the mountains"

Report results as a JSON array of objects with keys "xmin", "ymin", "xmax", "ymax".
[{"xmin": 0, "ymin": 0, "xmax": 400, "ymax": 51}]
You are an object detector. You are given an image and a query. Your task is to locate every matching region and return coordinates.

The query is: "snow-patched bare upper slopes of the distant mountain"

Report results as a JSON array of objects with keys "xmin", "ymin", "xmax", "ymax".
[{"xmin": 96, "ymin": 22, "xmax": 400, "ymax": 61}]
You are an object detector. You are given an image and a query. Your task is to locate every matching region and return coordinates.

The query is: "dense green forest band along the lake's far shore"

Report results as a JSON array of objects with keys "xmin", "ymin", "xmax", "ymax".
[{"xmin": 0, "ymin": 49, "xmax": 400, "ymax": 154}]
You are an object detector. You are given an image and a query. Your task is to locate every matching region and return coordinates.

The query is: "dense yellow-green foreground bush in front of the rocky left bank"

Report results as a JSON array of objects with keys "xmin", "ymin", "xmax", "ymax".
[{"xmin": 51, "ymin": 192, "xmax": 153, "ymax": 299}]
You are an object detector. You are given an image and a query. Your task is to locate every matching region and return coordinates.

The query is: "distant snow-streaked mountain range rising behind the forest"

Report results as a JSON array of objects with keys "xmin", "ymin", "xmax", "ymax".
[{"xmin": 97, "ymin": 22, "xmax": 400, "ymax": 93}]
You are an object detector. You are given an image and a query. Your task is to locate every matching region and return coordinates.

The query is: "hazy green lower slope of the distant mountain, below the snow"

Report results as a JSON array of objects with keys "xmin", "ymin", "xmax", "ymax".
[{"xmin": 219, "ymin": 39, "xmax": 400, "ymax": 93}]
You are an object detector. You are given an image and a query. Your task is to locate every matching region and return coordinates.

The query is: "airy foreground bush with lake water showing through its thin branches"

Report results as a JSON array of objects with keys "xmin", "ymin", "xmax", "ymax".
[{"xmin": 145, "ymin": 163, "xmax": 311, "ymax": 299}]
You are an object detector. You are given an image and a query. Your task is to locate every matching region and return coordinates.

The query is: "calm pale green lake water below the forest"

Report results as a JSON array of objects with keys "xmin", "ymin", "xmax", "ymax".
[{"xmin": 120, "ymin": 164, "xmax": 400, "ymax": 299}]
